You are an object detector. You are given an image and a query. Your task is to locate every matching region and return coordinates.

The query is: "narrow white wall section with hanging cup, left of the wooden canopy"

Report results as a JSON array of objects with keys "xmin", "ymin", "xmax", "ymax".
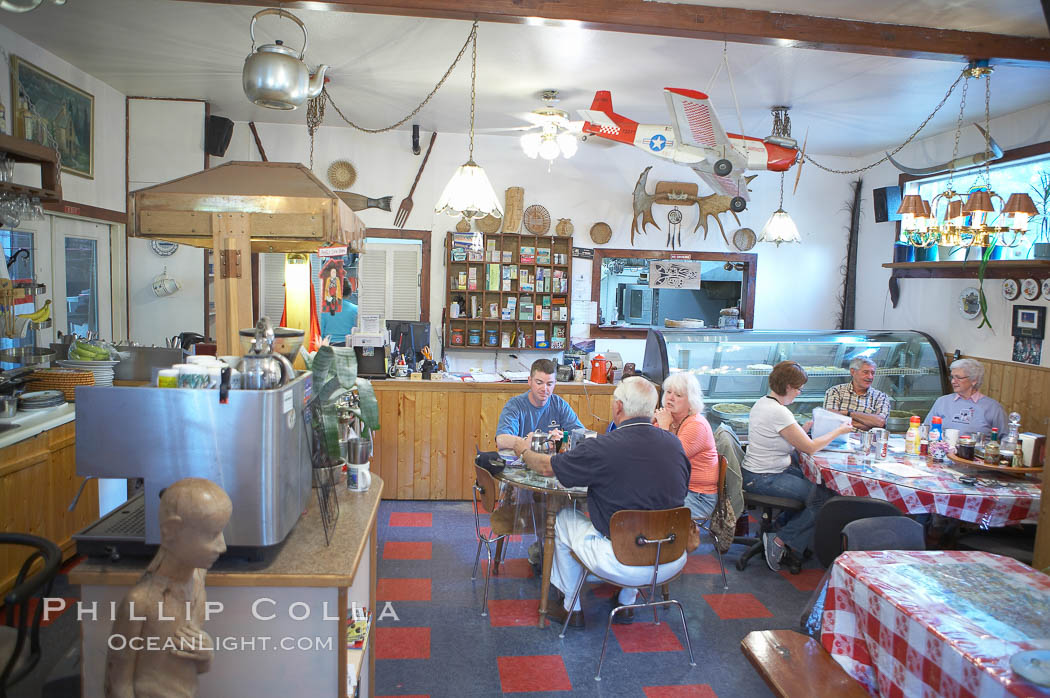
[{"xmin": 127, "ymin": 99, "xmax": 205, "ymax": 346}]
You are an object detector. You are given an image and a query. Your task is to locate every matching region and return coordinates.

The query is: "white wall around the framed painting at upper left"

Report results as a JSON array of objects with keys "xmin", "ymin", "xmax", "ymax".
[{"xmin": 0, "ymin": 24, "xmax": 125, "ymax": 211}]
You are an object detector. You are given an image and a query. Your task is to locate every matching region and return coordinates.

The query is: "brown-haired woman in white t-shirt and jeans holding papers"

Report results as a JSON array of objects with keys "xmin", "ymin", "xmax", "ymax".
[{"xmin": 741, "ymin": 361, "xmax": 853, "ymax": 571}]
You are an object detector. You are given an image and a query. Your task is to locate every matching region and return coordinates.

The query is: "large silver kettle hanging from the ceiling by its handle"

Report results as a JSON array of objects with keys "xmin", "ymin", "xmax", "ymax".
[{"xmin": 240, "ymin": 7, "xmax": 329, "ymax": 109}]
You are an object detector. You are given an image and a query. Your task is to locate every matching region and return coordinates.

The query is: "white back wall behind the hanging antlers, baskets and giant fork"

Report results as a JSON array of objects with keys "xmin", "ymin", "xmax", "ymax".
[{"xmin": 212, "ymin": 114, "xmax": 849, "ymax": 369}]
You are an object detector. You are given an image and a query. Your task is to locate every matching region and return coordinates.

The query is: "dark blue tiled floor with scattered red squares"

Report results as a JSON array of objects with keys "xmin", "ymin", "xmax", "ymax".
[{"xmin": 375, "ymin": 502, "xmax": 822, "ymax": 698}]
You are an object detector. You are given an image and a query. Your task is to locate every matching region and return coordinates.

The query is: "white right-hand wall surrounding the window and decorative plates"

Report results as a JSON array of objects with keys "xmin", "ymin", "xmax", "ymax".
[{"xmin": 857, "ymin": 102, "xmax": 1050, "ymax": 366}]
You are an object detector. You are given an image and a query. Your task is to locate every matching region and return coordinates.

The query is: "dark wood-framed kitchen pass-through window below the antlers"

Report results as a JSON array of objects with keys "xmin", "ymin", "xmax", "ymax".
[{"xmin": 591, "ymin": 250, "xmax": 756, "ymax": 337}]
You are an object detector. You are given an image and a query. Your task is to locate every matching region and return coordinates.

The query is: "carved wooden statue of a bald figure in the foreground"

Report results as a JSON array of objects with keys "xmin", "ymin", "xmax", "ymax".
[{"xmin": 105, "ymin": 478, "xmax": 233, "ymax": 698}]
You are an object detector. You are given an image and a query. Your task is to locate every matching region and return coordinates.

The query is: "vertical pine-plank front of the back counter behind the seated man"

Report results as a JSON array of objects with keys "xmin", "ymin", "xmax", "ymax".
[{"xmin": 372, "ymin": 380, "xmax": 615, "ymax": 500}]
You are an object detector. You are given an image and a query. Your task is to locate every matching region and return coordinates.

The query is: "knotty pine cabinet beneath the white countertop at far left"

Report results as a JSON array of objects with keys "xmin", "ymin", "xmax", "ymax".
[{"xmin": 0, "ymin": 422, "xmax": 99, "ymax": 594}]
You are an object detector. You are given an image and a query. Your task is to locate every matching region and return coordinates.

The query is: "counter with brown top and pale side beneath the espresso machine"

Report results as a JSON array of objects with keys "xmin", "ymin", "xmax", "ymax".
[{"xmin": 69, "ymin": 475, "xmax": 383, "ymax": 698}]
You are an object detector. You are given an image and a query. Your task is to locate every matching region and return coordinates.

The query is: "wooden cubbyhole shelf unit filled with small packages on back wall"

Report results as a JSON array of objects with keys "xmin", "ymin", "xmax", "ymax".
[{"xmin": 442, "ymin": 232, "xmax": 572, "ymax": 352}]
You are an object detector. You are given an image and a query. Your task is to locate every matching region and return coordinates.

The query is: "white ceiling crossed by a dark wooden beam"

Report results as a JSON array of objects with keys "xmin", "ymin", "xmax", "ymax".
[{"xmin": 2, "ymin": 0, "xmax": 1050, "ymax": 155}]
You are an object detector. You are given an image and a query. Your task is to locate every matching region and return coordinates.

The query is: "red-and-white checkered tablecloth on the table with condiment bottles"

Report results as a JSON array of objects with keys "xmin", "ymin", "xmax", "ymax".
[{"xmin": 801, "ymin": 451, "xmax": 1041, "ymax": 527}]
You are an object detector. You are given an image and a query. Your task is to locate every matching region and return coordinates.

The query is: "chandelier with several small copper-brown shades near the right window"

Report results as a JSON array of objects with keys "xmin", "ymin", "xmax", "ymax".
[{"xmin": 897, "ymin": 61, "xmax": 1037, "ymax": 248}]
